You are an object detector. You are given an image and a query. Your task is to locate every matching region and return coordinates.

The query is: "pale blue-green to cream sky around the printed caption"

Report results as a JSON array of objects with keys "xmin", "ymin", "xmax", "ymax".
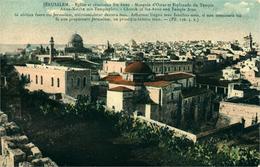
[{"xmin": 0, "ymin": 0, "xmax": 260, "ymax": 44}]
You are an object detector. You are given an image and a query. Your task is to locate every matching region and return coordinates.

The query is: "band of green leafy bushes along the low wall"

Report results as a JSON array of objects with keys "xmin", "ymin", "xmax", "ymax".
[{"xmin": 37, "ymin": 97, "xmax": 260, "ymax": 166}]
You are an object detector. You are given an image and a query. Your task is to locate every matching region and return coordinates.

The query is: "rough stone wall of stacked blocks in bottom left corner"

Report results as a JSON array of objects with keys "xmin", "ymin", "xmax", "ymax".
[{"xmin": 0, "ymin": 111, "xmax": 58, "ymax": 167}]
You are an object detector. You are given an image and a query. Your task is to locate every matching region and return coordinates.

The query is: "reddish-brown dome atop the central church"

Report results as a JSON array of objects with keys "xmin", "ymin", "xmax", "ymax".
[{"xmin": 125, "ymin": 61, "xmax": 152, "ymax": 74}]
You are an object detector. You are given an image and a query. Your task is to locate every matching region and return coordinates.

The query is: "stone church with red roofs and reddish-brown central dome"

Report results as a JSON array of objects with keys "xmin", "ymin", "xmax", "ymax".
[{"xmin": 103, "ymin": 62, "xmax": 211, "ymax": 126}]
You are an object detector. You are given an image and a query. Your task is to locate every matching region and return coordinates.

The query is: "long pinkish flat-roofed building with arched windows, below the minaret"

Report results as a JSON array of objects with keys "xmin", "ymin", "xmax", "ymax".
[{"xmin": 15, "ymin": 64, "xmax": 91, "ymax": 98}]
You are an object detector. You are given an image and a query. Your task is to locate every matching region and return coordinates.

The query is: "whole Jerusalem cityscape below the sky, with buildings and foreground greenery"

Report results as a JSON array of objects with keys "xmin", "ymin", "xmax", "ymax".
[{"xmin": 0, "ymin": 32, "xmax": 260, "ymax": 167}]
